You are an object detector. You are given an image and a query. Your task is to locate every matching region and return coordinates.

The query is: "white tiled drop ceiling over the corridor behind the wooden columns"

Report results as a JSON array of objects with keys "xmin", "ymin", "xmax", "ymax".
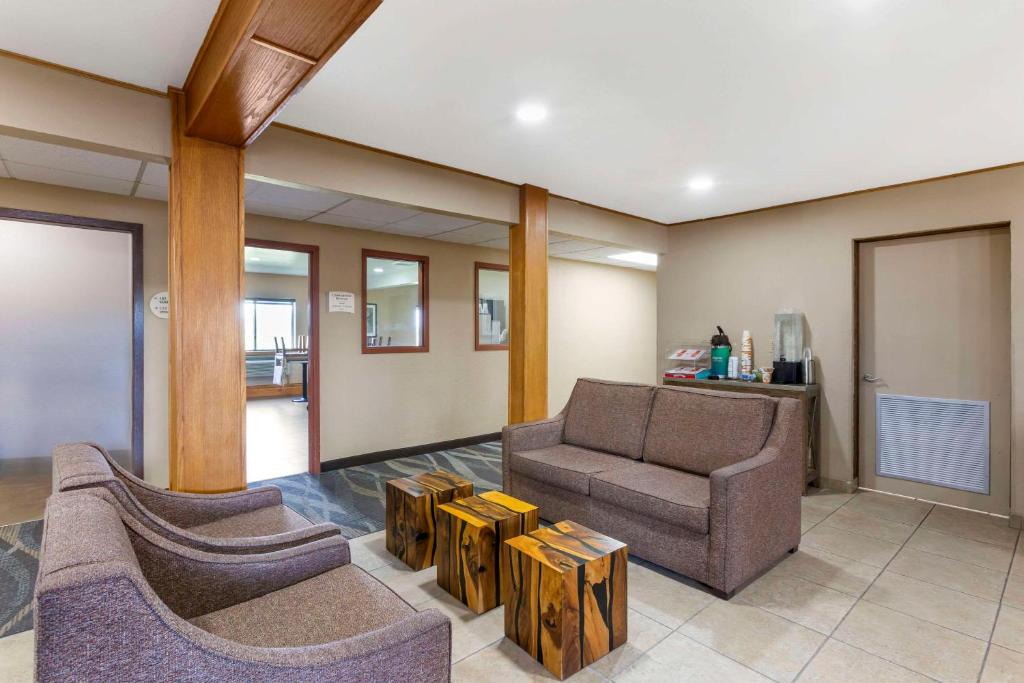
[{"xmin": 0, "ymin": 135, "xmax": 654, "ymax": 274}]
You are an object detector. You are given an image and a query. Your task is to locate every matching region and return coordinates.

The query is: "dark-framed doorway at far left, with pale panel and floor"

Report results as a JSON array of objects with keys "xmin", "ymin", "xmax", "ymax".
[{"xmin": 0, "ymin": 208, "xmax": 143, "ymax": 525}]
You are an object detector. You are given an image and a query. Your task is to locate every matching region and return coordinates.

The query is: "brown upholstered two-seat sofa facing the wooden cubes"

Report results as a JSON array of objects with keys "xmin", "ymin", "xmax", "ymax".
[{"xmin": 502, "ymin": 379, "xmax": 804, "ymax": 597}]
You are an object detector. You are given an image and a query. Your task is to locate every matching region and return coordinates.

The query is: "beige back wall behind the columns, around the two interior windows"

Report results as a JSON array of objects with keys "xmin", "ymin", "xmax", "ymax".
[{"xmin": 0, "ymin": 179, "xmax": 655, "ymax": 485}]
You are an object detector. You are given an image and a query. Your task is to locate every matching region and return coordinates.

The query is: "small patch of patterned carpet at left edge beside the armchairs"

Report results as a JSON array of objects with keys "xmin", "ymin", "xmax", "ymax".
[{"xmin": 0, "ymin": 520, "xmax": 43, "ymax": 638}]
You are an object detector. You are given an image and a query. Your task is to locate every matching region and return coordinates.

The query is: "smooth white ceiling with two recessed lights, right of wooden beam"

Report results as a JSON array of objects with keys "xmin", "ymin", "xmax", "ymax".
[{"xmin": 281, "ymin": 0, "xmax": 1024, "ymax": 221}]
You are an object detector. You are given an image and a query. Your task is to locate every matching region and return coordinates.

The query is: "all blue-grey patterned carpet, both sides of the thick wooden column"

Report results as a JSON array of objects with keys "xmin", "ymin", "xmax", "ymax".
[{"xmin": 0, "ymin": 442, "xmax": 502, "ymax": 638}]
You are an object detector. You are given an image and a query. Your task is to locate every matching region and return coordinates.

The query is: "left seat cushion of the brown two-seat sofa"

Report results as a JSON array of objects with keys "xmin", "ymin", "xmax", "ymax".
[{"xmin": 511, "ymin": 443, "xmax": 635, "ymax": 496}]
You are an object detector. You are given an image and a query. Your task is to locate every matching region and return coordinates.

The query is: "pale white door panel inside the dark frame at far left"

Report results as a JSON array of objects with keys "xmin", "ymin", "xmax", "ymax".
[{"xmin": 0, "ymin": 219, "xmax": 132, "ymax": 466}]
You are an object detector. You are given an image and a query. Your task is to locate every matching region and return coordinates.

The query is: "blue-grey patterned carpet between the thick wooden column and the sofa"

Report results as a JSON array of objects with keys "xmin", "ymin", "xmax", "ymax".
[{"xmin": 250, "ymin": 441, "xmax": 502, "ymax": 539}]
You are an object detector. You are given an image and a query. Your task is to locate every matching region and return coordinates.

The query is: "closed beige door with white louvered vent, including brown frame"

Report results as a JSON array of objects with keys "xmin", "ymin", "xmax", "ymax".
[{"xmin": 854, "ymin": 223, "xmax": 1011, "ymax": 515}]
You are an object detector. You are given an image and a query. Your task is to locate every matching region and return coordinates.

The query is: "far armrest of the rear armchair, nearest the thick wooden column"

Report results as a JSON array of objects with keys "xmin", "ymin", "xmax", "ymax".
[{"xmin": 121, "ymin": 479, "xmax": 284, "ymax": 528}]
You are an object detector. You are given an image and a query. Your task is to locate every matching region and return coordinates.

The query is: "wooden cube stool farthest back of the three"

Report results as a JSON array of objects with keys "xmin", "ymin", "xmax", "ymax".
[{"xmin": 385, "ymin": 470, "xmax": 473, "ymax": 571}]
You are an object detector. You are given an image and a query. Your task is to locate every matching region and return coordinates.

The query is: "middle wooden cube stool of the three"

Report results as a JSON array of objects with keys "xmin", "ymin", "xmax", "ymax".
[{"xmin": 437, "ymin": 490, "xmax": 538, "ymax": 614}]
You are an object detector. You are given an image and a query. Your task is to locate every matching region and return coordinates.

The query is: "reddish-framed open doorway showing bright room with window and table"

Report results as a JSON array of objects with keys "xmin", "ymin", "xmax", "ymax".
[{"xmin": 243, "ymin": 239, "xmax": 319, "ymax": 482}]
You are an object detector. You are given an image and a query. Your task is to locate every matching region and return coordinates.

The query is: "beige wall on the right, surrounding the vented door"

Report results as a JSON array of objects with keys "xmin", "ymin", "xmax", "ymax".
[{"xmin": 657, "ymin": 167, "xmax": 1024, "ymax": 514}]
